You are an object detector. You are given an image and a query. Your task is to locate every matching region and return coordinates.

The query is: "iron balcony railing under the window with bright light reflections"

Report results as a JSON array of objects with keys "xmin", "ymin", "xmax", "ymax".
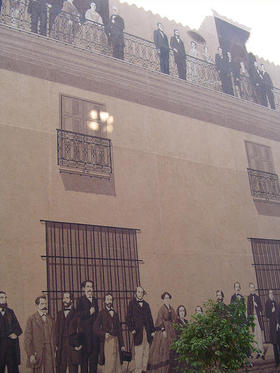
[{"xmin": 57, "ymin": 129, "xmax": 112, "ymax": 179}]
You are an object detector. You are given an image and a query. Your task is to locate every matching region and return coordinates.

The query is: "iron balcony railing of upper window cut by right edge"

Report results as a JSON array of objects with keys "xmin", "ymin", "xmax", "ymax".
[{"xmin": 248, "ymin": 168, "xmax": 280, "ymax": 200}]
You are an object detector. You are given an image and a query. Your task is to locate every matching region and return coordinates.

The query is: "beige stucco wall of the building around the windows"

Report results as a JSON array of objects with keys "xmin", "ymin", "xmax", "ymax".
[{"xmin": 0, "ymin": 70, "xmax": 280, "ymax": 370}]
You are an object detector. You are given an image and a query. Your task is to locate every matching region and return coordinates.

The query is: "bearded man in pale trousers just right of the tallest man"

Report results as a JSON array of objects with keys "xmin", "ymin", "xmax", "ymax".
[{"xmin": 93, "ymin": 293, "xmax": 125, "ymax": 373}]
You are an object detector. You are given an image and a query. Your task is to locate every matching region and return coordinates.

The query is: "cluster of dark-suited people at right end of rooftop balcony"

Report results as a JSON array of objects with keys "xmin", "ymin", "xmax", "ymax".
[{"xmin": 215, "ymin": 47, "xmax": 275, "ymax": 110}]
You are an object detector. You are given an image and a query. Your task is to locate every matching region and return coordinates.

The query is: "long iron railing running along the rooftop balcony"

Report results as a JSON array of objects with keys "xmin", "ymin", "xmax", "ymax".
[{"xmin": 0, "ymin": 0, "xmax": 280, "ymax": 110}]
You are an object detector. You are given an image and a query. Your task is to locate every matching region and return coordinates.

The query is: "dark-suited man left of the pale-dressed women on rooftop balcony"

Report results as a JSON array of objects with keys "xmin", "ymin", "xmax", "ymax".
[{"xmin": 27, "ymin": 0, "xmax": 48, "ymax": 36}]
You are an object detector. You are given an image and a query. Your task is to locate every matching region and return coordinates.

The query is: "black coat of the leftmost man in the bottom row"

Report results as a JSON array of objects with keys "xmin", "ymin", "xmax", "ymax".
[{"xmin": 0, "ymin": 308, "xmax": 22, "ymax": 365}]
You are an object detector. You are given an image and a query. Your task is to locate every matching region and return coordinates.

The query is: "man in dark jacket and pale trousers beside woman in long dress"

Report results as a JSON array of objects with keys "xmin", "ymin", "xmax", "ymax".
[{"xmin": 126, "ymin": 286, "xmax": 155, "ymax": 373}]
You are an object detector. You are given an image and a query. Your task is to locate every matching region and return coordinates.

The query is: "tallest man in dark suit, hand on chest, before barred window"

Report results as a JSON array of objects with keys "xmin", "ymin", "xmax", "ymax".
[{"xmin": 77, "ymin": 280, "xmax": 98, "ymax": 373}]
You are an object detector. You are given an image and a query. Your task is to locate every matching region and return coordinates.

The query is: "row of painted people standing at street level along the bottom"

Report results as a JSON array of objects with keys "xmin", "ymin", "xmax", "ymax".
[{"xmin": 0, "ymin": 280, "xmax": 280, "ymax": 373}]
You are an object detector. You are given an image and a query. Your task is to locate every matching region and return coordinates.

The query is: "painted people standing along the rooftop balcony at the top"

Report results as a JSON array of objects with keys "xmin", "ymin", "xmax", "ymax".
[{"xmin": 0, "ymin": 0, "xmax": 275, "ymax": 110}]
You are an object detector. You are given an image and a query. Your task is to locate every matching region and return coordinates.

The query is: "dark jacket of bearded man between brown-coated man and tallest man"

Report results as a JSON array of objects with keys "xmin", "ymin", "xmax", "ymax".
[{"xmin": 55, "ymin": 307, "xmax": 76, "ymax": 366}]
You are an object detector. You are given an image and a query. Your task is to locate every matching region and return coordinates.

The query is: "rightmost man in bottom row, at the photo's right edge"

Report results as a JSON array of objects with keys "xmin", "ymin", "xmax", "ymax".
[{"xmin": 265, "ymin": 290, "xmax": 280, "ymax": 366}]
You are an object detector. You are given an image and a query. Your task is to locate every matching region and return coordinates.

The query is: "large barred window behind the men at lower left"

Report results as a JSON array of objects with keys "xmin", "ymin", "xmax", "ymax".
[{"xmin": 44, "ymin": 221, "xmax": 141, "ymax": 347}]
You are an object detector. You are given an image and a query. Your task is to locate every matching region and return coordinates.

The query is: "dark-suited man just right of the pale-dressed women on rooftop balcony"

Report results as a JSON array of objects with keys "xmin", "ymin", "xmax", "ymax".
[{"xmin": 108, "ymin": 6, "xmax": 125, "ymax": 60}]
